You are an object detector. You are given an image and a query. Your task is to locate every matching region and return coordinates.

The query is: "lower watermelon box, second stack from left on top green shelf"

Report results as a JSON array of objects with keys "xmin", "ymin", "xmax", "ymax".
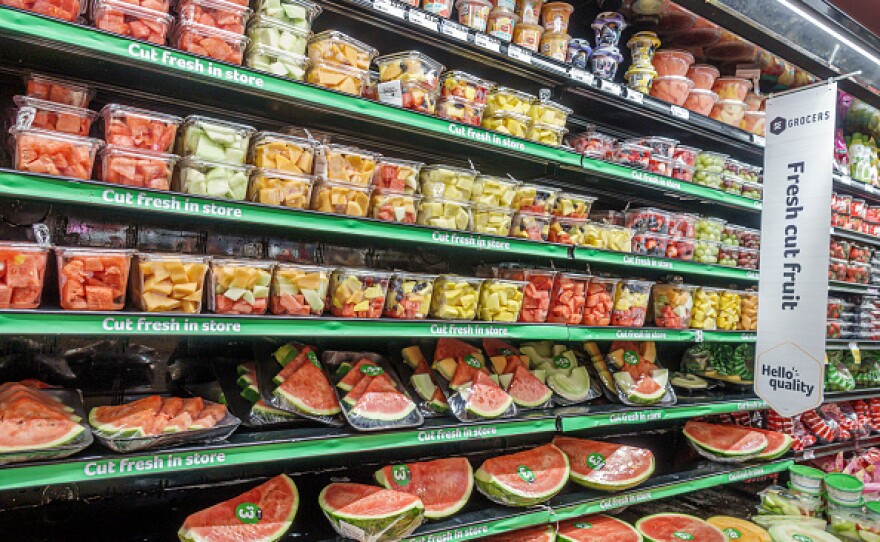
[{"xmin": 92, "ymin": 0, "xmax": 174, "ymax": 45}]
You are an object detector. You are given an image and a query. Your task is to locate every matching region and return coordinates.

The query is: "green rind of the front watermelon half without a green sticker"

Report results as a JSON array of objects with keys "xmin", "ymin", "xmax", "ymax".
[{"xmin": 318, "ymin": 484, "xmax": 425, "ymax": 541}]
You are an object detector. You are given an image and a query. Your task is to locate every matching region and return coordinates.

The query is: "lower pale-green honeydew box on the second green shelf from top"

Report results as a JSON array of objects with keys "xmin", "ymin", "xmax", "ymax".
[{"xmin": 174, "ymin": 157, "xmax": 254, "ymax": 200}]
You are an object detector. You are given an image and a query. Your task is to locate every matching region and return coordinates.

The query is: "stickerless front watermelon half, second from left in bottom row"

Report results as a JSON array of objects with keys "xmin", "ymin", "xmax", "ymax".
[{"xmin": 318, "ymin": 483, "xmax": 425, "ymax": 542}]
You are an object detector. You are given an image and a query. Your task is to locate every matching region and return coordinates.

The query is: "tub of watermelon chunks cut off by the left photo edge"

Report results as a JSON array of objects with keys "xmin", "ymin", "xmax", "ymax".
[{"xmin": 0, "ymin": 242, "xmax": 49, "ymax": 309}]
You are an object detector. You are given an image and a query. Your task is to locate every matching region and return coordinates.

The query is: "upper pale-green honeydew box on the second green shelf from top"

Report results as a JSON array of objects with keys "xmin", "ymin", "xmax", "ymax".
[{"xmin": 177, "ymin": 115, "xmax": 256, "ymax": 165}]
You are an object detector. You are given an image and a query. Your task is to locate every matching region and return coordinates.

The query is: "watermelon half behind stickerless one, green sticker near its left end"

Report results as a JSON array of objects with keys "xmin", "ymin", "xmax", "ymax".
[{"xmin": 376, "ymin": 457, "xmax": 474, "ymax": 519}]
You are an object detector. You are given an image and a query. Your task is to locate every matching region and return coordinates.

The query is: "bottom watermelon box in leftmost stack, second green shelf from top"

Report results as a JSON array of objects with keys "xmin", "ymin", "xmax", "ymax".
[{"xmin": 10, "ymin": 128, "xmax": 104, "ymax": 180}]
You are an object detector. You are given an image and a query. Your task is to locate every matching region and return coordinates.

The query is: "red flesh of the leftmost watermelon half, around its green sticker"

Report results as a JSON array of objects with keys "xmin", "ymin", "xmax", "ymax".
[{"xmin": 177, "ymin": 474, "xmax": 299, "ymax": 542}]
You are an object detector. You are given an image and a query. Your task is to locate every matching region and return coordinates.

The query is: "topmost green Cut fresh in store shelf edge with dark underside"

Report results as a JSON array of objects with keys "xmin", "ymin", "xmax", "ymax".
[{"xmin": 0, "ymin": 7, "xmax": 761, "ymax": 212}]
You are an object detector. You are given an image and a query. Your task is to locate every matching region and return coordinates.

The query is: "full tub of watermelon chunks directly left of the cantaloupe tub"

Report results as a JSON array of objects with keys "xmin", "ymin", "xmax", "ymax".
[{"xmin": 55, "ymin": 247, "xmax": 135, "ymax": 311}]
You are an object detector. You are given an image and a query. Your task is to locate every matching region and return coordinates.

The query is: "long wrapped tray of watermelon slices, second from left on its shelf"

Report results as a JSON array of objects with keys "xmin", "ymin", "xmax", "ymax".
[{"xmin": 89, "ymin": 395, "xmax": 241, "ymax": 453}]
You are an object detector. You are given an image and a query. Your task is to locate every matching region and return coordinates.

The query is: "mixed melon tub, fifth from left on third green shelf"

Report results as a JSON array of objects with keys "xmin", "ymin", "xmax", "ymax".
[{"xmin": 270, "ymin": 263, "xmax": 333, "ymax": 316}]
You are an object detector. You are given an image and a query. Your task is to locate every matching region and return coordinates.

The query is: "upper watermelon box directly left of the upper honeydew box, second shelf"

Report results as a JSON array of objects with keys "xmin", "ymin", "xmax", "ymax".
[{"xmin": 100, "ymin": 104, "xmax": 183, "ymax": 152}]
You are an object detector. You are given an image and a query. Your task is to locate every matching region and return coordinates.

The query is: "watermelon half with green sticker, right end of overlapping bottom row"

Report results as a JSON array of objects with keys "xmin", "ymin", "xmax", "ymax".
[{"xmin": 553, "ymin": 437, "xmax": 654, "ymax": 491}]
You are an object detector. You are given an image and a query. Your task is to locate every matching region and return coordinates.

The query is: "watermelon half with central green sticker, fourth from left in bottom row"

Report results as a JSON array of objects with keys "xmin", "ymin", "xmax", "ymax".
[{"xmin": 475, "ymin": 444, "xmax": 570, "ymax": 506}]
